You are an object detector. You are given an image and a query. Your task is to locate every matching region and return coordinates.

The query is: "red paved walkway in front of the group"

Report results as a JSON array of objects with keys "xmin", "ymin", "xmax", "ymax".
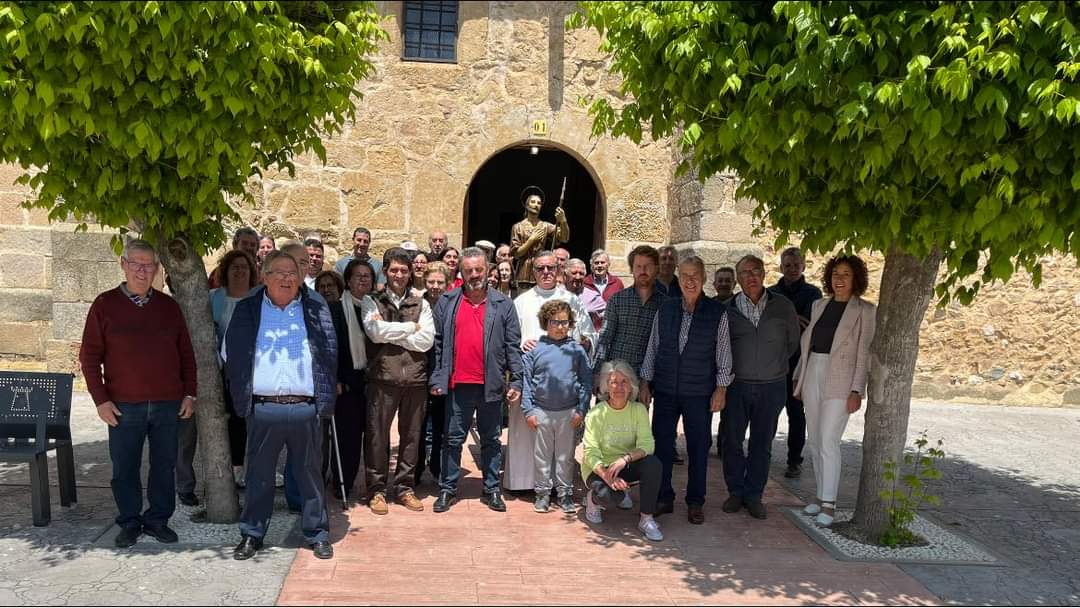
[{"xmin": 278, "ymin": 440, "xmax": 937, "ymax": 605}]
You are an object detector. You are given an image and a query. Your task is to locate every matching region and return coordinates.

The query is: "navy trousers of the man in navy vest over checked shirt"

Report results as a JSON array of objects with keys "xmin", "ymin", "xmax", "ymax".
[{"xmin": 652, "ymin": 392, "xmax": 713, "ymax": 505}]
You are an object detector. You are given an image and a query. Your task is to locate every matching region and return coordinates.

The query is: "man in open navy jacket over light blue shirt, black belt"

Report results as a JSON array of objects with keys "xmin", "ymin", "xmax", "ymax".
[{"xmin": 221, "ymin": 252, "xmax": 337, "ymax": 559}]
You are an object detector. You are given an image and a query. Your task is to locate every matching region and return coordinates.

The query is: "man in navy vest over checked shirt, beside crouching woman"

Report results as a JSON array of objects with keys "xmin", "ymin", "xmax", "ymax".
[{"xmin": 638, "ymin": 256, "xmax": 732, "ymax": 524}]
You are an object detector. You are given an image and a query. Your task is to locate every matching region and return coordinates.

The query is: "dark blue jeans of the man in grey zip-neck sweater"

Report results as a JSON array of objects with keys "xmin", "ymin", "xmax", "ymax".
[{"xmin": 723, "ymin": 379, "xmax": 787, "ymax": 500}]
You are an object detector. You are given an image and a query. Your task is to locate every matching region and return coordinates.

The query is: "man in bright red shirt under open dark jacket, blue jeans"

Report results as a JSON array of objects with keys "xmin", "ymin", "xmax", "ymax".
[{"xmin": 430, "ymin": 247, "xmax": 522, "ymax": 513}]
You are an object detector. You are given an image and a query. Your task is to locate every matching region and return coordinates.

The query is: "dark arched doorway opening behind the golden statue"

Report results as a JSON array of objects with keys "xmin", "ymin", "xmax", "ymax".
[{"xmin": 462, "ymin": 141, "xmax": 606, "ymax": 261}]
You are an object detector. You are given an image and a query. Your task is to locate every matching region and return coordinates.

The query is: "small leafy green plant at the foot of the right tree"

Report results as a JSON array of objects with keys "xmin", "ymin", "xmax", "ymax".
[{"xmin": 879, "ymin": 431, "xmax": 945, "ymax": 548}]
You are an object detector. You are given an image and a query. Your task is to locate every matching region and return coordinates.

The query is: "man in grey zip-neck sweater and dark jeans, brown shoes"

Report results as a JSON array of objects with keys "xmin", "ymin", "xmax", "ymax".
[{"xmin": 721, "ymin": 255, "xmax": 799, "ymax": 519}]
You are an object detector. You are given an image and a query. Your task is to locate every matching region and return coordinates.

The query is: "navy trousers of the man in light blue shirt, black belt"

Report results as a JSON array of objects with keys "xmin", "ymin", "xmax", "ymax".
[{"xmin": 240, "ymin": 403, "xmax": 329, "ymax": 542}]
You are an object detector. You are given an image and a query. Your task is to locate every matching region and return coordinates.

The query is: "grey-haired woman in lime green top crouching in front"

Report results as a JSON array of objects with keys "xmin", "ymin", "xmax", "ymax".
[{"xmin": 581, "ymin": 360, "xmax": 664, "ymax": 541}]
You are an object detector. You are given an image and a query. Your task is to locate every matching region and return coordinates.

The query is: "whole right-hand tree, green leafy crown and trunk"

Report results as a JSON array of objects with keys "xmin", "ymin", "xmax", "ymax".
[{"xmin": 568, "ymin": 2, "xmax": 1080, "ymax": 539}]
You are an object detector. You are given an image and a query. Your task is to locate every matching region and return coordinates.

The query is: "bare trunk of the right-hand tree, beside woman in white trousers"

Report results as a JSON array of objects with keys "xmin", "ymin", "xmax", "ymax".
[{"xmin": 854, "ymin": 249, "xmax": 942, "ymax": 539}]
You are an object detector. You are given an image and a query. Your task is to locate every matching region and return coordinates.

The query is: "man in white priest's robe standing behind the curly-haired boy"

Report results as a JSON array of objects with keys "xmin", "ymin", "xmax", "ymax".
[{"xmin": 502, "ymin": 252, "xmax": 598, "ymax": 491}]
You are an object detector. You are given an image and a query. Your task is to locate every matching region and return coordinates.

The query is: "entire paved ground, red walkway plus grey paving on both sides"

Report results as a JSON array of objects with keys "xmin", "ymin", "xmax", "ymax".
[{"xmin": 0, "ymin": 394, "xmax": 1080, "ymax": 605}]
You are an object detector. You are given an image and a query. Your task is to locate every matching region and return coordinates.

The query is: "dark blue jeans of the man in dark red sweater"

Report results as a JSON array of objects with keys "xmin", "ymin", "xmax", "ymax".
[{"xmin": 109, "ymin": 401, "xmax": 180, "ymax": 528}]
